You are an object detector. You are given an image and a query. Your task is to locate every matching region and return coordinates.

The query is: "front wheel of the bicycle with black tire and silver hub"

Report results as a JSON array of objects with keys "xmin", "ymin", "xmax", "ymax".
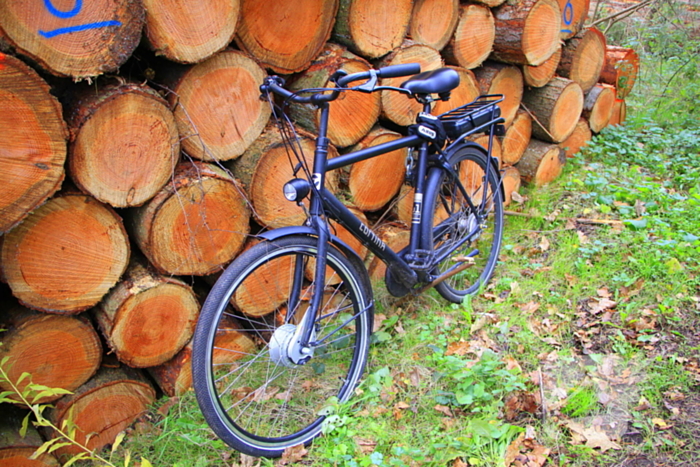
[{"xmin": 192, "ymin": 235, "xmax": 373, "ymax": 457}]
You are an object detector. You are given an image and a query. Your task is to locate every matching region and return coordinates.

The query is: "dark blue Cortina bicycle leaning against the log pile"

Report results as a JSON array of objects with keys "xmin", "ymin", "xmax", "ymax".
[{"xmin": 192, "ymin": 64, "xmax": 504, "ymax": 457}]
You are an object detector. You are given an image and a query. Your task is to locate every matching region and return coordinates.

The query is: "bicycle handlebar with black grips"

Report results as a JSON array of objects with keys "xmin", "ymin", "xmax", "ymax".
[{"xmin": 260, "ymin": 63, "xmax": 420, "ymax": 105}]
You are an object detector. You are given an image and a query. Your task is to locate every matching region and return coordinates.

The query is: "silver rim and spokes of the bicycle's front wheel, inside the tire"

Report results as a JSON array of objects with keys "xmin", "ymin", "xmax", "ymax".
[{"xmin": 201, "ymin": 241, "xmax": 368, "ymax": 449}]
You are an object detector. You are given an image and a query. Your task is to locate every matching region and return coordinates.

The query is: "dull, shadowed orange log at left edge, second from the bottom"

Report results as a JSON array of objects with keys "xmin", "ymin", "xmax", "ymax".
[{"xmin": 0, "ymin": 306, "xmax": 102, "ymax": 404}]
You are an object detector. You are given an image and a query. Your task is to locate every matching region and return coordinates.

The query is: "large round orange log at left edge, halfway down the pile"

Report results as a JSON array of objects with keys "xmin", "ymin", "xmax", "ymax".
[{"xmin": 2, "ymin": 194, "xmax": 130, "ymax": 314}]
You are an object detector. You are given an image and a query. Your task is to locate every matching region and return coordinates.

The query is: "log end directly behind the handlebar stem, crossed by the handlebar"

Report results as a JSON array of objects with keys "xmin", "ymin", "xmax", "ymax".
[{"xmin": 288, "ymin": 43, "xmax": 381, "ymax": 147}]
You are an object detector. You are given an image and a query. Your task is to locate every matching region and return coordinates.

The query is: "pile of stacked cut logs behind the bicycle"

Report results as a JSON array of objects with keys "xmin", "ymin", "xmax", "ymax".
[{"xmin": 0, "ymin": 0, "xmax": 639, "ymax": 465}]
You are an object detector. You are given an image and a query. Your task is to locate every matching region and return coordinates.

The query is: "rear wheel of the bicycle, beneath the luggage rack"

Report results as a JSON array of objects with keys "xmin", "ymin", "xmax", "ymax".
[{"xmin": 423, "ymin": 143, "xmax": 503, "ymax": 303}]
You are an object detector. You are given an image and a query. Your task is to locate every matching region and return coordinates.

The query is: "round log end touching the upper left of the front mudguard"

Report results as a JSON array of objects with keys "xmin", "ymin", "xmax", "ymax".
[{"xmin": 129, "ymin": 161, "xmax": 250, "ymax": 276}]
